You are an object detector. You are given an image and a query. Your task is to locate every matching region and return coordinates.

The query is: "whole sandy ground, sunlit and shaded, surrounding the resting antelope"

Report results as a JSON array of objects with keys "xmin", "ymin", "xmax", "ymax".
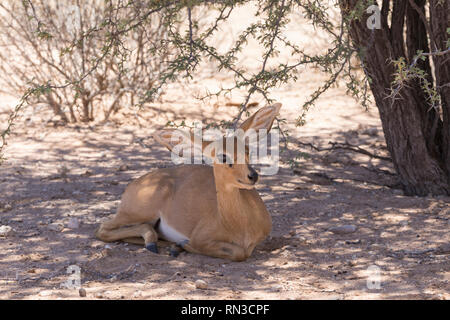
[{"xmin": 0, "ymin": 5, "xmax": 450, "ymax": 299}]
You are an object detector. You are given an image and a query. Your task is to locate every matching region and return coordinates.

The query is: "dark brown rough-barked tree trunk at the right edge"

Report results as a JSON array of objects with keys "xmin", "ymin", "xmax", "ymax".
[{"xmin": 340, "ymin": 0, "xmax": 450, "ymax": 196}]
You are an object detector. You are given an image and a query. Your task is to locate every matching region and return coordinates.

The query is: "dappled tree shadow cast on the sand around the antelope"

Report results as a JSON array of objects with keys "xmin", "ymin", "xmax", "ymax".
[{"xmin": 0, "ymin": 119, "xmax": 450, "ymax": 299}]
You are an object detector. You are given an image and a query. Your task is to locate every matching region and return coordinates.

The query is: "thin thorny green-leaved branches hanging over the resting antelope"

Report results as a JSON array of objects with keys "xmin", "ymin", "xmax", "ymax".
[{"xmin": 2, "ymin": 0, "xmax": 371, "ymax": 162}]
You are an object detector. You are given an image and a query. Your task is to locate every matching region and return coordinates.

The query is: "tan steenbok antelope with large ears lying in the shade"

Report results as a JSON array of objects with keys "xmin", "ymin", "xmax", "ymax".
[{"xmin": 96, "ymin": 103, "xmax": 281, "ymax": 261}]
